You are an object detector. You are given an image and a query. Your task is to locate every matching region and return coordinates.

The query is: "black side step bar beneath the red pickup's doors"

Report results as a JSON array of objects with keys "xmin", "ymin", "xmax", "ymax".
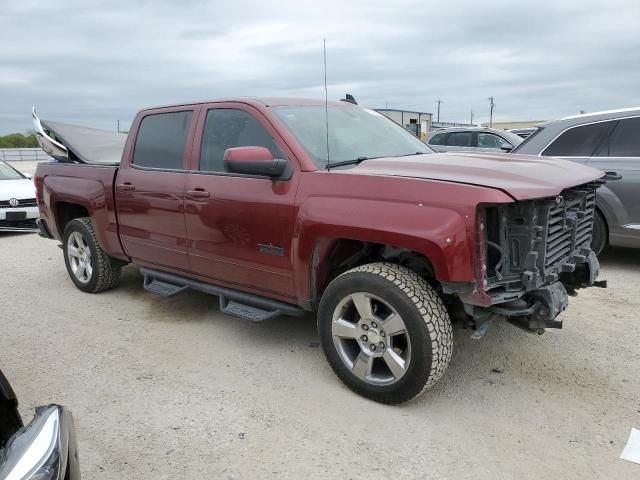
[{"xmin": 140, "ymin": 267, "xmax": 306, "ymax": 322}]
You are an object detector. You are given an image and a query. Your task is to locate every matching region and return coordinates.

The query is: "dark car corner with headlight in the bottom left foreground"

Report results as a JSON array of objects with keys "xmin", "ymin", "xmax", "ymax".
[{"xmin": 0, "ymin": 371, "xmax": 80, "ymax": 480}]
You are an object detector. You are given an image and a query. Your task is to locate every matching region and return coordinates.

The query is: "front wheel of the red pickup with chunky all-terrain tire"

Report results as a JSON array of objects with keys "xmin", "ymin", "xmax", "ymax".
[{"xmin": 318, "ymin": 263, "xmax": 453, "ymax": 404}]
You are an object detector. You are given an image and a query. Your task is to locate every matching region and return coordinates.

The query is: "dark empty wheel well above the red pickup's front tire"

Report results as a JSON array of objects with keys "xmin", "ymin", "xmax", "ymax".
[{"xmin": 310, "ymin": 239, "xmax": 438, "ymax": 304}]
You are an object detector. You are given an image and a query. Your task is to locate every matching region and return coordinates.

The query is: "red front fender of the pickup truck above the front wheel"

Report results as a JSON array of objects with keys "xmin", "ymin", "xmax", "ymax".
[{"xmin": 293, "ymin": 198, "xmax": 474, "ymax": 299}]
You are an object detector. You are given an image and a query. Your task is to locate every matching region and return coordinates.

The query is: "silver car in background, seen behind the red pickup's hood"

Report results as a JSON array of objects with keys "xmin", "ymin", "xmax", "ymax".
[{"xmin": 425, "ymin": 127, "xmax": 522, "ymax": 153}]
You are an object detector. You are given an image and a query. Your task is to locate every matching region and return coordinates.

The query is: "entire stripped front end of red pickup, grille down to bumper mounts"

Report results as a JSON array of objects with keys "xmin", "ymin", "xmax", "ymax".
[{"xmin": 443, "ymin": 180, "xmax": 606, "ymax": 338}]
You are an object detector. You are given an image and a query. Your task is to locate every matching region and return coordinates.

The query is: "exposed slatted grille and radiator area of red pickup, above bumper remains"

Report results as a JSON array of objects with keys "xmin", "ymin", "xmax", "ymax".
[{"xmin": 483, "ymin": 181, "xmax": 602, "ymax": 298}]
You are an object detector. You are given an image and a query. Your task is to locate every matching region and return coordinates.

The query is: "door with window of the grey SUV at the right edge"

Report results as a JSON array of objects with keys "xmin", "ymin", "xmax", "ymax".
[{"xmin": 587, "ymin": 117, "xmax": 640, "ymax": 246}]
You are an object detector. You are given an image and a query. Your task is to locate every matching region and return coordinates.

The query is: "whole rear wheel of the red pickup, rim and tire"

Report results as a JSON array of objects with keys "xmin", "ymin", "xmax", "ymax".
[{"xmin": 63, "ymin": 217, "xmax": 121, "ymax": 293}]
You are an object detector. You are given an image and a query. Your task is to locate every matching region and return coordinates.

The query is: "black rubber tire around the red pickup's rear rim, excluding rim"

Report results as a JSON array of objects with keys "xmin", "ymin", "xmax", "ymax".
[{"xmin": 62, "ymin": 217, "xmax": 121, "ymax": 293}]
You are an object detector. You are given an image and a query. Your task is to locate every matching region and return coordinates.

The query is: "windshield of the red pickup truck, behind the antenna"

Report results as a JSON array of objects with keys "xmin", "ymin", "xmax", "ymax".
[{"xmin": 273, "ymin": 105, "xmax": 433, "ymax": 168}]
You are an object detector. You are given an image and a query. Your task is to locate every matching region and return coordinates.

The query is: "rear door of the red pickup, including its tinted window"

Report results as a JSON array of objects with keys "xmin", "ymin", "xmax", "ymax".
[{"xmin": 115, "ymin": 107, "xmax": 196, "ymax": 270}]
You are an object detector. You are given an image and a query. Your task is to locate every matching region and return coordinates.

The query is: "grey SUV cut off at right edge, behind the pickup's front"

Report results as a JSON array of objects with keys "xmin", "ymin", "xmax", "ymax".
[{"xmin": 513, "ymin": 107, "xmax": 640, "ymax": 253}]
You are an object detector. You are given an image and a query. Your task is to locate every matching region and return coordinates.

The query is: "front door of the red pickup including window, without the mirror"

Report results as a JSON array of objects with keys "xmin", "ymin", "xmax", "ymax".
[{"xmin": 185, "ymin": 103, "xmax": 299, "ymax": 297}]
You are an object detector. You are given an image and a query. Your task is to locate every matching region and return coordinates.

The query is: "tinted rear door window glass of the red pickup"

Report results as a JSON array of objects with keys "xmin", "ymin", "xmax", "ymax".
[{"xmin": 132, "ymin": 111, "xmax": 192, "ymax": 170}]
